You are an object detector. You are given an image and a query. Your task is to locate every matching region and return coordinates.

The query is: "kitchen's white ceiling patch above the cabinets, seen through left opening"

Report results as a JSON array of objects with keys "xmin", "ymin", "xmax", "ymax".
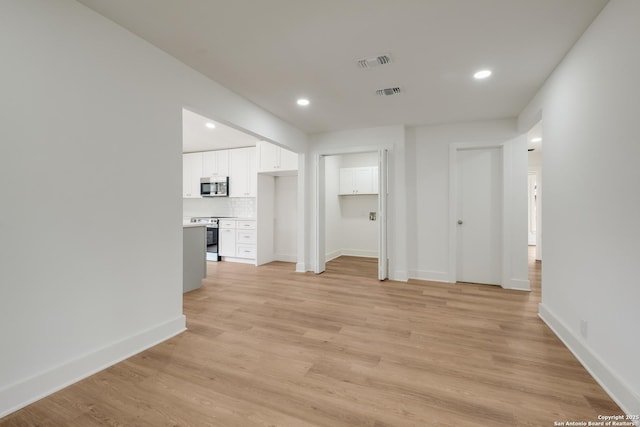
[{"xmin": 182, "ymin": 109, "xmax": 258, "ymax": 153}]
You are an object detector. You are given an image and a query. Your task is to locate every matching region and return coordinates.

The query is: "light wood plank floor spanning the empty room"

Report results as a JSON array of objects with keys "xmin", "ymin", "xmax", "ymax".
[{"xmin": 0, "ymin": 249, "xmax": 621, "ymax": 427}]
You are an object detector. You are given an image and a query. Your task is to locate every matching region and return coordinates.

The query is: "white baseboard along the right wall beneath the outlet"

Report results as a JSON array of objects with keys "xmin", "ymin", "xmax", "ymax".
[{"xmin": 538, "ymin": 303, "xmax": 640, "ymax": 414}]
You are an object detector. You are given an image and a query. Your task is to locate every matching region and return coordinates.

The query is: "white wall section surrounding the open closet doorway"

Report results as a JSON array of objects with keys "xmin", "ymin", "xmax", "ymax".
[{"xmin": 305, "ymin": 126, "xmax": 407, "ymax": 281}]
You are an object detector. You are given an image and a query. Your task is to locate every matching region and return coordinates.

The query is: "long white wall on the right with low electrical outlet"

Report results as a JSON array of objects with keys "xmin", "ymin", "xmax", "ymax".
[{"xmin": 519, "ymin": 0, "xmax": 640, "ymax": 414}]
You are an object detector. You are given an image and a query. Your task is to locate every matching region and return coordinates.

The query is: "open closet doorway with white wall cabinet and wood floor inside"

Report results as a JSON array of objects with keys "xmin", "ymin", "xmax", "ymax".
[{"xmin": 314, "ymin": 150, "xmax": 388, "ymax": 280}]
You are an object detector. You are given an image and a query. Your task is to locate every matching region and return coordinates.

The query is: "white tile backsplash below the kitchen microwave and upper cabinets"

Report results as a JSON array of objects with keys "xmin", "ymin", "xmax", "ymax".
[{"xmin": 182, "ymin": 197, "xmax": 256, "ymax": 219}]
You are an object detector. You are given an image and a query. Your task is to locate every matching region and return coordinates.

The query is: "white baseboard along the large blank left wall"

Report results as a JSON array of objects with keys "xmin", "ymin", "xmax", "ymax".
[{"xmin": 0, "ymin": 315, "xmax": 186, "ymax": 418}]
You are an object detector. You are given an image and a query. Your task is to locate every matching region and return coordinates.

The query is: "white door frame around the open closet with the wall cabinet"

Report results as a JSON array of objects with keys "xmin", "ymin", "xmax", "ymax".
[{"xmin": 313, "ymin": 146, "xmax": 390, "ymax": 280}]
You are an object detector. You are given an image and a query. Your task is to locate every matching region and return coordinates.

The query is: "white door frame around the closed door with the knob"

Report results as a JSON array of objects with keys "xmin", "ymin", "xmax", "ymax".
[{"xmin": 449, "ymin": 143, "xmax": 511, "ymax": 288}]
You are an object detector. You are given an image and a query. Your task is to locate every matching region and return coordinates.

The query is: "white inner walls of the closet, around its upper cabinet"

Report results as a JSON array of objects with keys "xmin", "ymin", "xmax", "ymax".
[{"xmin": 325, "ymin": 151, "xmax": 378, "ymax": 260}]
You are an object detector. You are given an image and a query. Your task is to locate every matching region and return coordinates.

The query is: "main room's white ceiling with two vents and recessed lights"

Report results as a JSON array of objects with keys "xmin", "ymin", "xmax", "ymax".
[{"xmin": 79, "ymin": 0, "xmax": 607, "ymax": 133}]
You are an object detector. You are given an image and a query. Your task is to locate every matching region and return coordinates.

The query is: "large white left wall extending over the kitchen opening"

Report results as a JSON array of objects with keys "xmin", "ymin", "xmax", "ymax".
[{"xmin": 0, "ymin": 0, "xmax": 306, "ymax": 416}]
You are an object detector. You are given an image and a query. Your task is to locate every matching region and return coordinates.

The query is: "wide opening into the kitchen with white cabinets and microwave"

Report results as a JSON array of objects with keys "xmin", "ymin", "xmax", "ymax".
[{"xmin": 182, "ymin": 109, "xmax": 298, "ymax": 269}]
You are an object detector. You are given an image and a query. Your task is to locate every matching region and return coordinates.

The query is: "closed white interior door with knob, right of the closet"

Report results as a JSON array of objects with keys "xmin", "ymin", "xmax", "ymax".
[{"xmin": 454, "ymin": 147, "xmax": 503, "ymax": 285}]
